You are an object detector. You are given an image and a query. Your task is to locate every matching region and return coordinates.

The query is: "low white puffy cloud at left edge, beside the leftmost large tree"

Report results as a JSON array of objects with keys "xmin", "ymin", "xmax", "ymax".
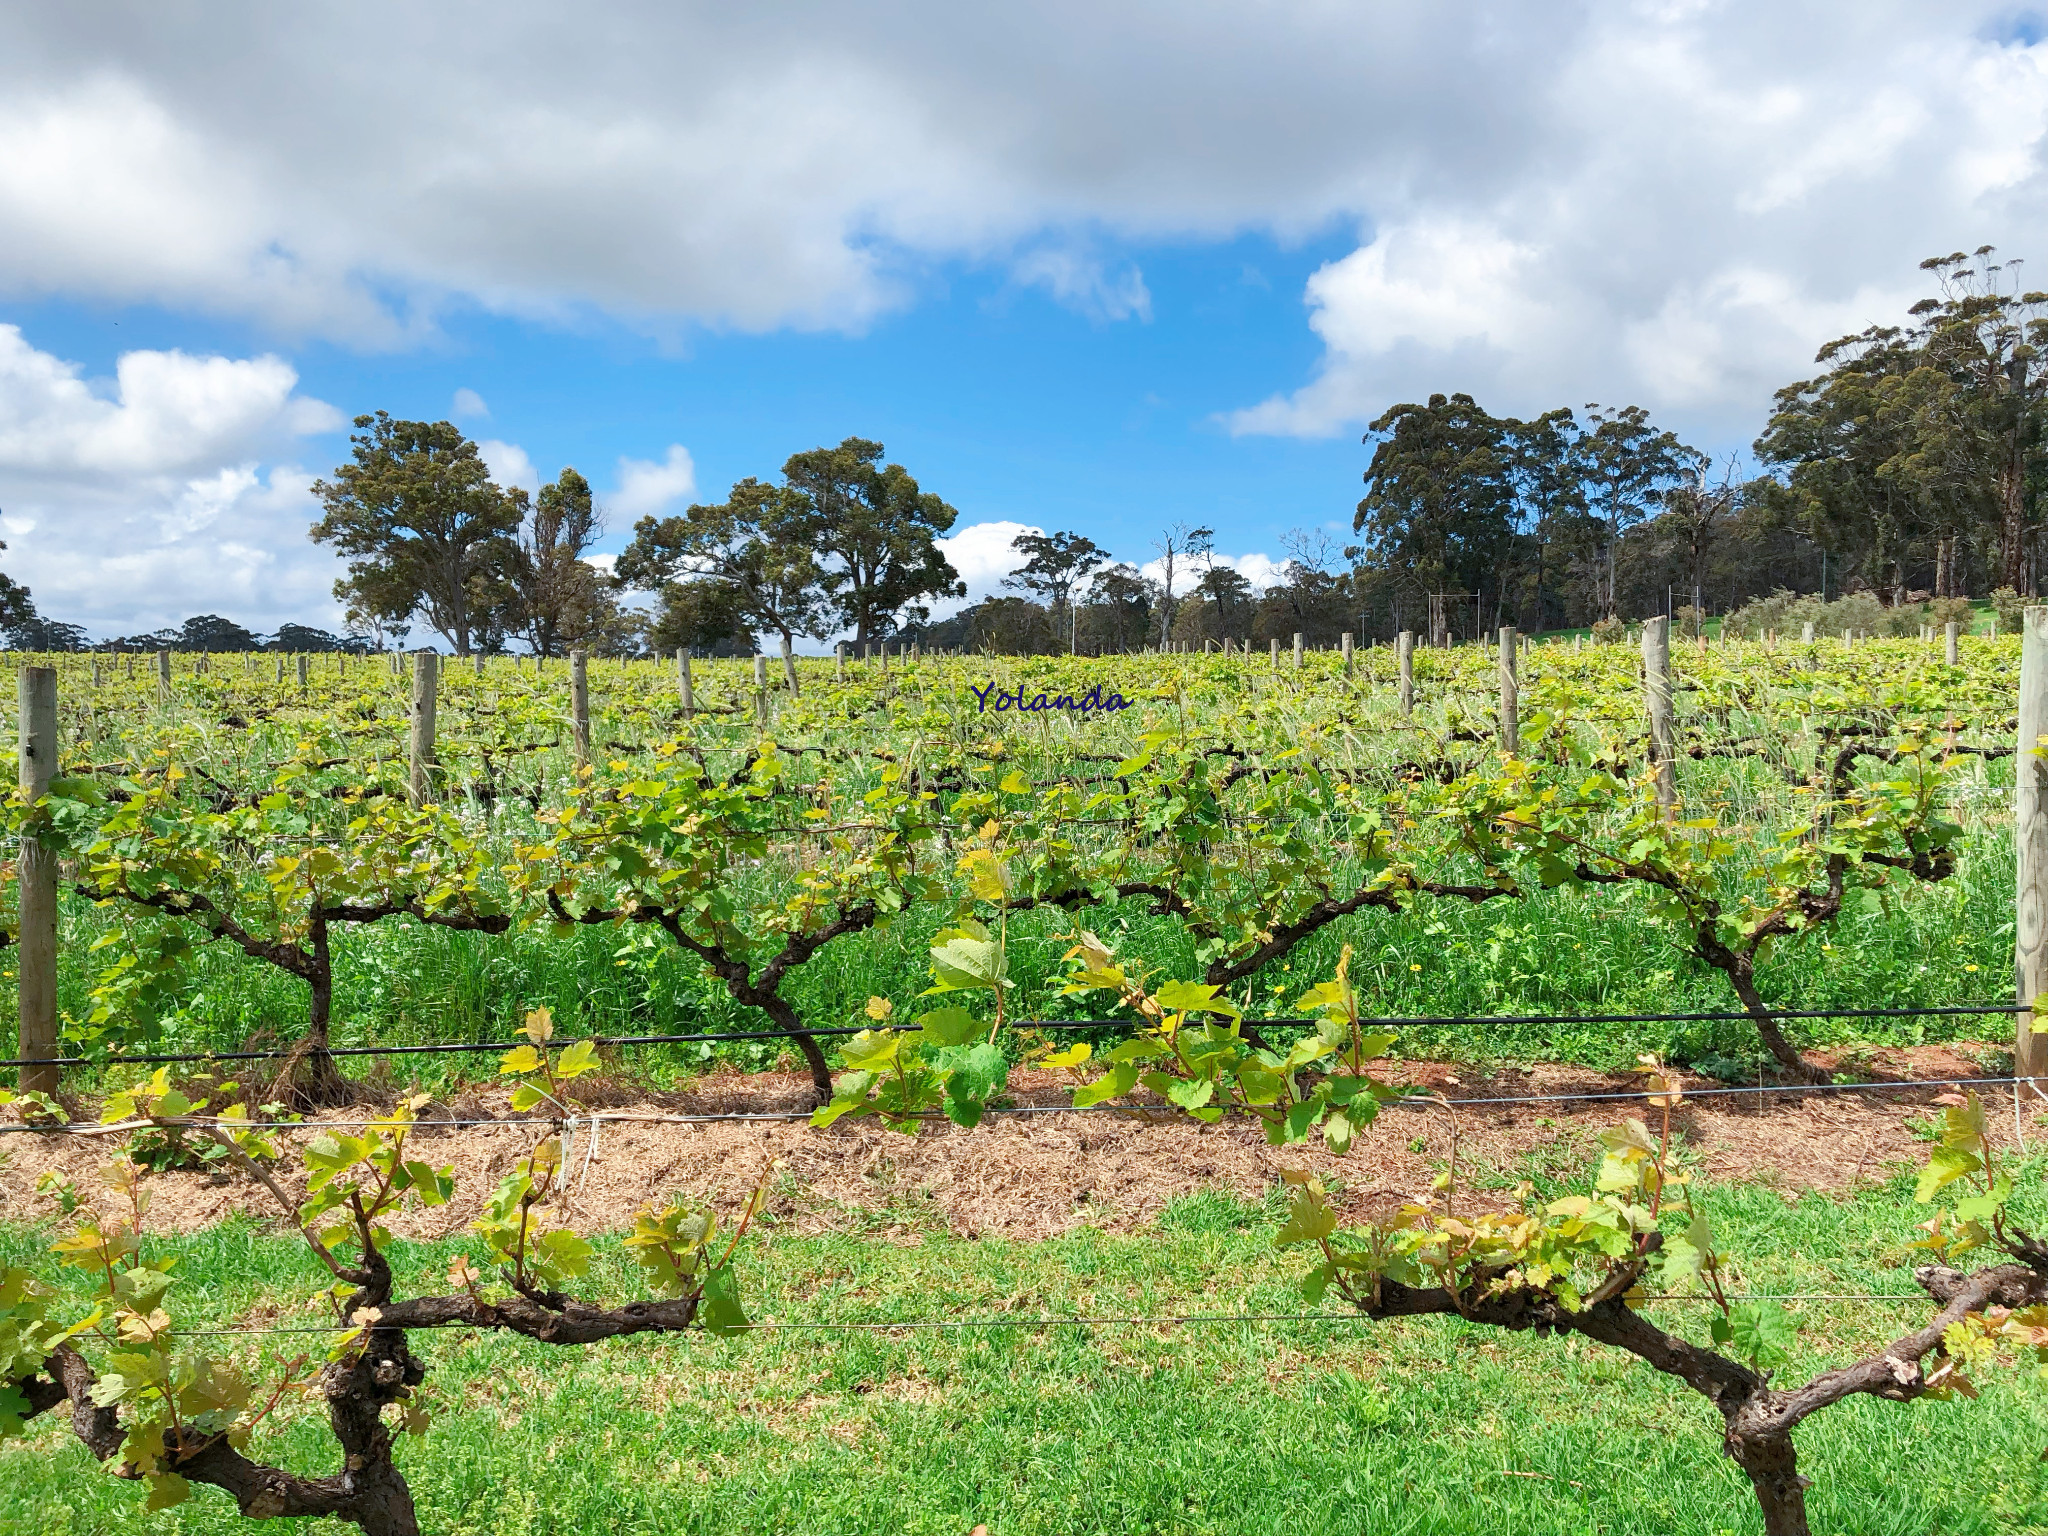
[{"xmin": 0, "ymin": 326, "xmax": 342, "ymax": 635}]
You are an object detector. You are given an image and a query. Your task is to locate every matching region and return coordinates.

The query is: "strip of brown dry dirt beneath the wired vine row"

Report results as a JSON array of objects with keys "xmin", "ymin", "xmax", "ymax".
[{"xmin": 0, "ymin": 1047, "xmax": 2015, "ymax": 1241}]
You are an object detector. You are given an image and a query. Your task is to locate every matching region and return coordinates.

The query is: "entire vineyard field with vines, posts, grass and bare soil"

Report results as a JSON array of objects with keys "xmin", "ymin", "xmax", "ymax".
[{"xmin": 0, "ymin": 625, "xmax": 2048, "ymax": 1536}]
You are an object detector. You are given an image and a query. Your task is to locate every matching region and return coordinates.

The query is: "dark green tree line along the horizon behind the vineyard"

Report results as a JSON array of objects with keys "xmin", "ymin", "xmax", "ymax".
[{"xmin": 0, "ymin": 246, "xmax": 2048, "ymax": 655}]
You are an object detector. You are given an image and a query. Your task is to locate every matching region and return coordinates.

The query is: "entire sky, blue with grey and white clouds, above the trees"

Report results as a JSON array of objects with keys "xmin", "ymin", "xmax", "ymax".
[{"xmin": 0, "ymin": 0, "xmax": 2048, "ymax": 637}]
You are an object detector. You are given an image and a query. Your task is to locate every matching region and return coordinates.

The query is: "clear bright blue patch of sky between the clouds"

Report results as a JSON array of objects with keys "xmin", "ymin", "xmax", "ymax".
[{"xmin": 12, "ymin": 231, "xmax": 1366, "ymax": 589}]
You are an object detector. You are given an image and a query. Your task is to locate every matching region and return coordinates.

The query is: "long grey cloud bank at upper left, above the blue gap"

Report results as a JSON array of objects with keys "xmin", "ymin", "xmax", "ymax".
[{"xmin": 0, "ymin": 0, "xmax": 1573, "ymax": 344}]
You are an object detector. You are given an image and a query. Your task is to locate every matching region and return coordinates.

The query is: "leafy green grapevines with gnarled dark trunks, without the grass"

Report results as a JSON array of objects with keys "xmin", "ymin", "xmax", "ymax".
[{"xmin": 0, "ymin": 641, "xmax": 2048, "ymax": 1536}]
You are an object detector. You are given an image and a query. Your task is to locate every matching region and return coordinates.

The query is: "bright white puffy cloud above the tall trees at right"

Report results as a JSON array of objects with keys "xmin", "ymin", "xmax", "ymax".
[{"xmin": 1225, "ymin": 0, "xmax": 2048, "ymax": 438}]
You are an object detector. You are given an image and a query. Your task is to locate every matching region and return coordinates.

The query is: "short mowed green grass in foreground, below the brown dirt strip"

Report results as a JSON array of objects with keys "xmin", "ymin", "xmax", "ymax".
[{"xmin": 0, "ymin": 1167, "xmax": 2048, "ymax": 1536}]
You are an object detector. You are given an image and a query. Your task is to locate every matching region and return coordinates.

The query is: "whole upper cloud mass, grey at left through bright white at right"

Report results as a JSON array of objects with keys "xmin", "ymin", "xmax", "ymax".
[{"xmin": 0, "ymin": 0, "xmax": 2048, "ymax": 483}]
